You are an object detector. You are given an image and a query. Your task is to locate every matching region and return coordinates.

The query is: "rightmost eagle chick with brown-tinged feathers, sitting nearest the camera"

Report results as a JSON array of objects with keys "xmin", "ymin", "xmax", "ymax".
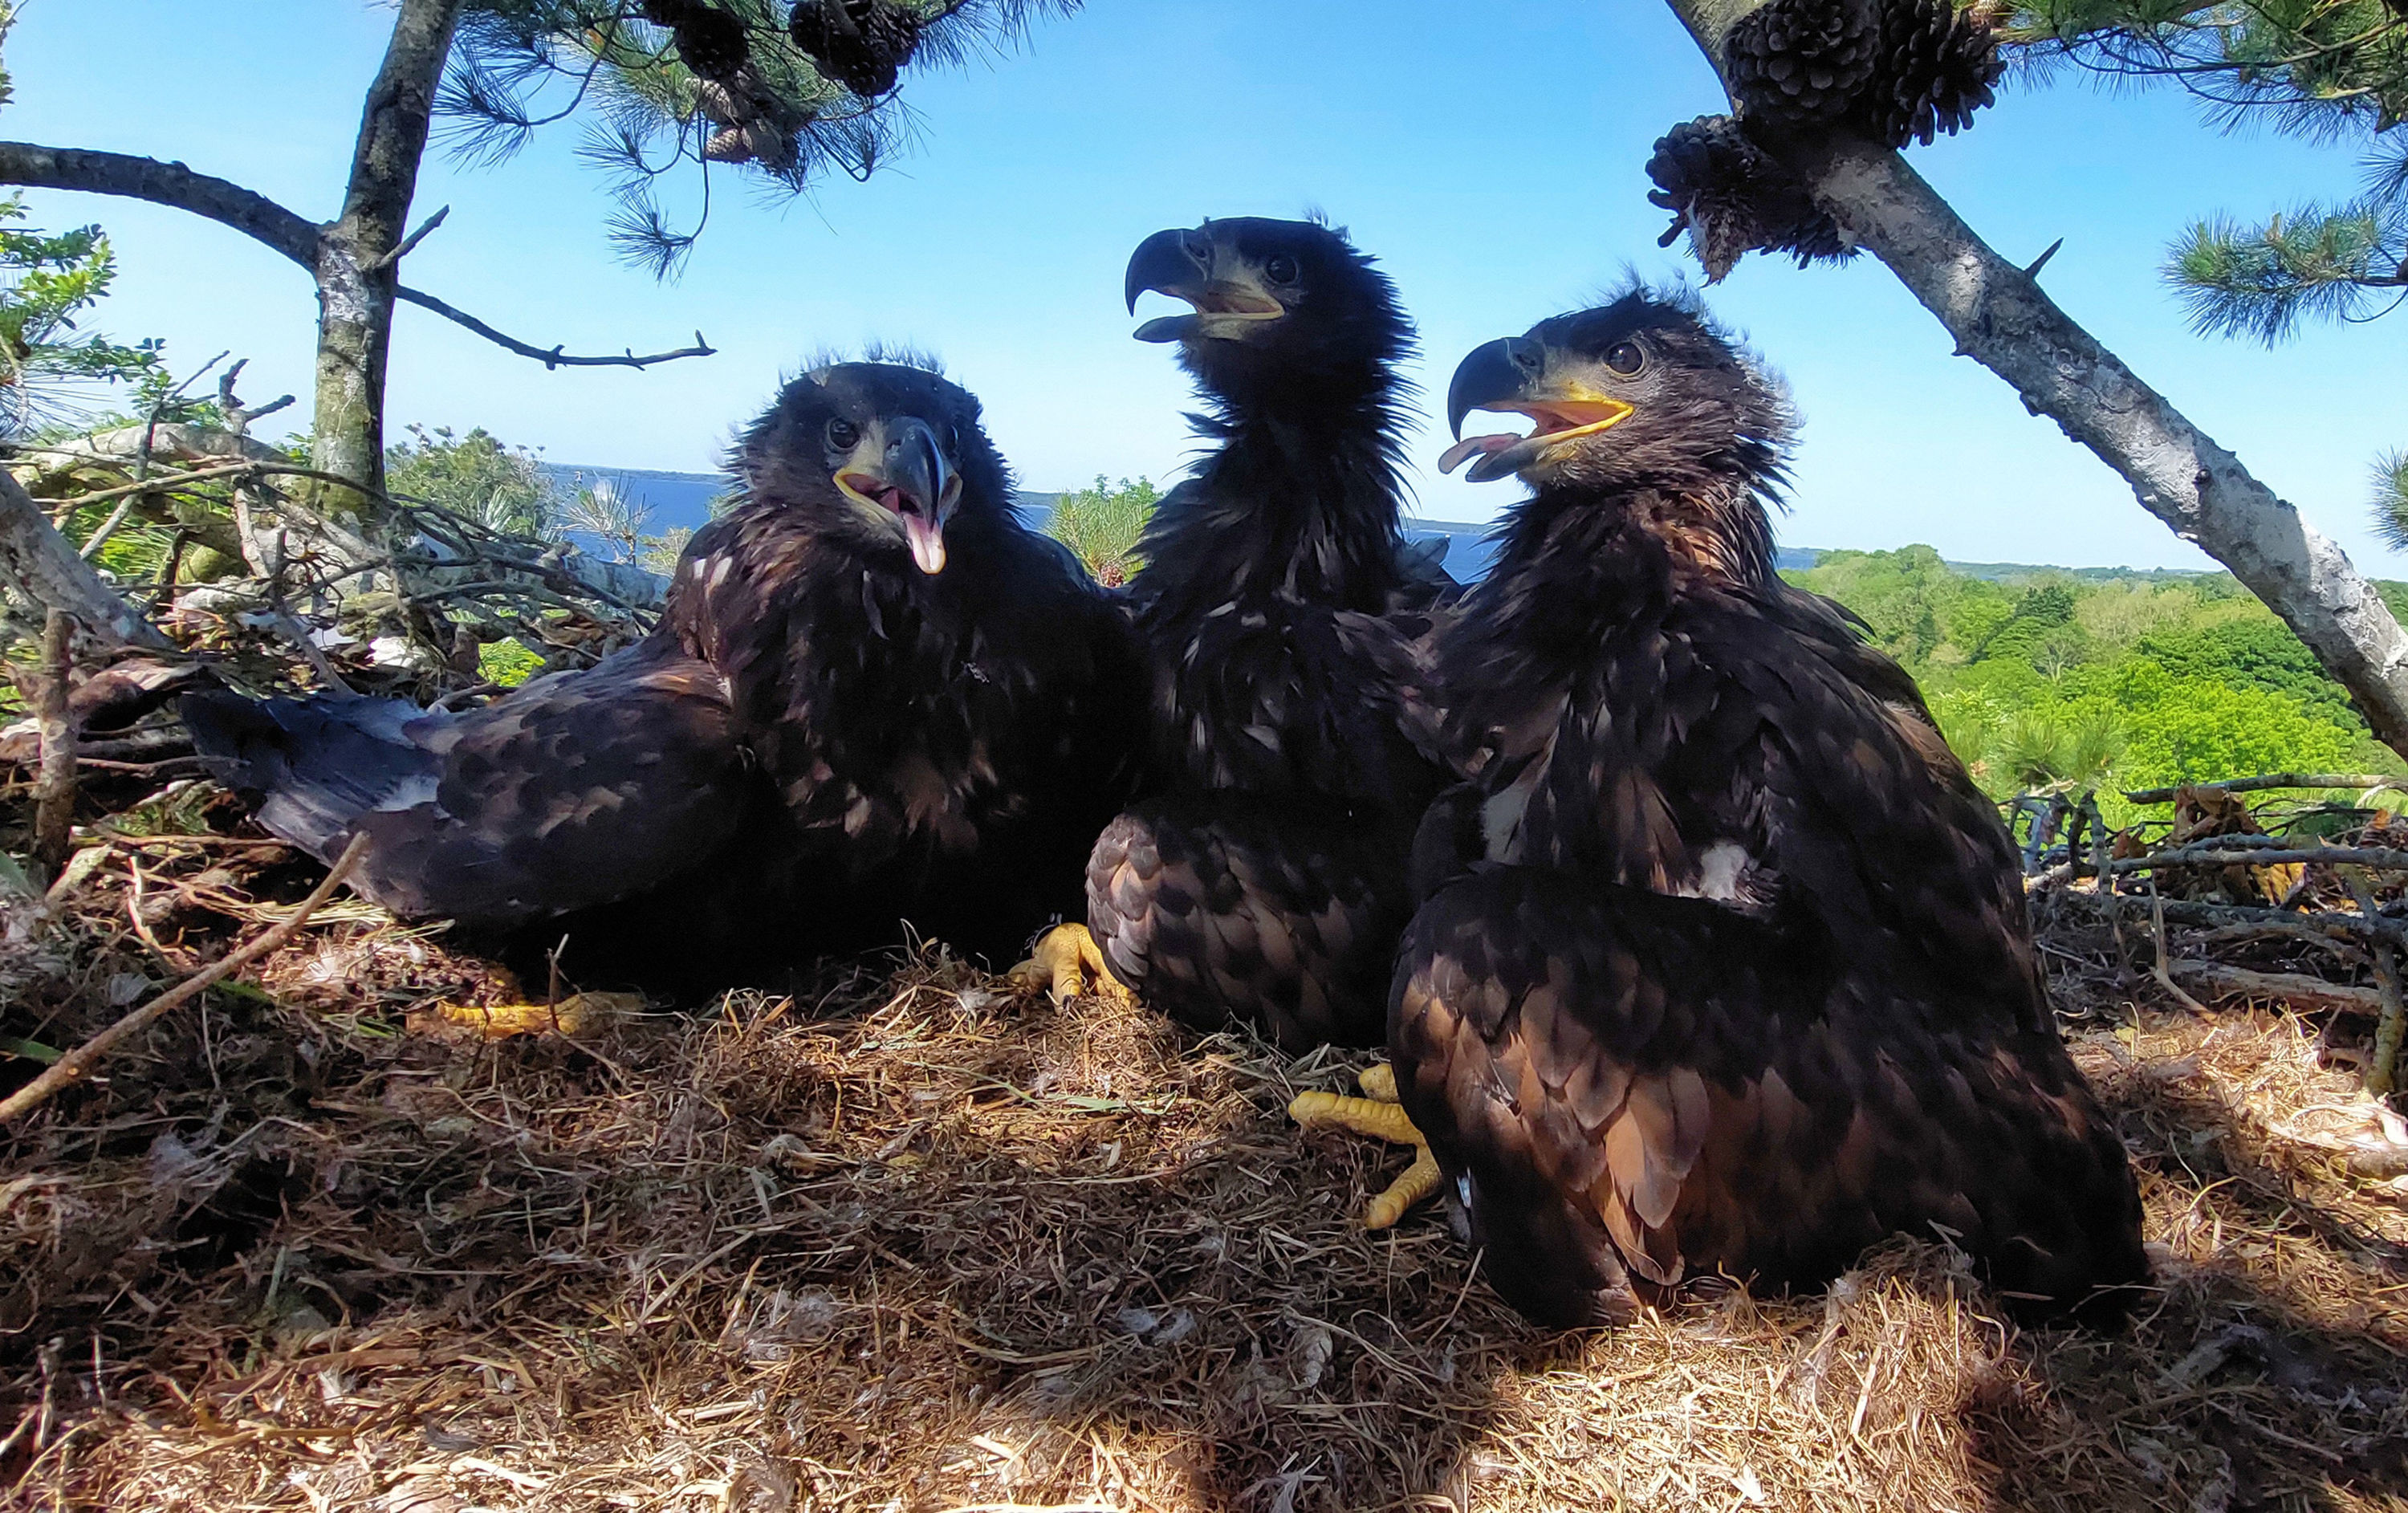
[{"xmin": 1389, "ymin": 294, "xmax": 2146, "ymax": 1323}]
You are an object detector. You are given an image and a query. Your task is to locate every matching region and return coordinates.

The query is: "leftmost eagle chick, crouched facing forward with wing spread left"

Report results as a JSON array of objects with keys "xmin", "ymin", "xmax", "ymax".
[{"xmin": 185, "ymin": 364, "xmax": 1137, "ymax": 976}]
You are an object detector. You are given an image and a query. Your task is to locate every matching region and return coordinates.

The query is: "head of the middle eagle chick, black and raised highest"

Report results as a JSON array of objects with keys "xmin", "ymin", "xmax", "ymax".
[{"xmin": 1125, "ymin": 217, "xmax": 1413, "ymax": 402}]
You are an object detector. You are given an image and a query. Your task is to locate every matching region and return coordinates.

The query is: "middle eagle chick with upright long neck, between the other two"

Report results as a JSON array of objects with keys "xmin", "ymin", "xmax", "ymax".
[{"xmin": 1088, "ymin": 219, "xmax": 1452, "ymax": 1046}]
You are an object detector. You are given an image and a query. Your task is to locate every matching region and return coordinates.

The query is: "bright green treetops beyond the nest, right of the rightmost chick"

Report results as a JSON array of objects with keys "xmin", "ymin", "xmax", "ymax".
[{"xmin": 1792, "ymin": 547, "xmax": 2408, "ymax": 820}]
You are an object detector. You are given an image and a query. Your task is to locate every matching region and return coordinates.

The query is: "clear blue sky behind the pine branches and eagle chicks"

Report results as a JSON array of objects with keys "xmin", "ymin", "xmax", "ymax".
[{"xmin": 0, "ymin": 0, "xmax": 2408, "ymax": 576}]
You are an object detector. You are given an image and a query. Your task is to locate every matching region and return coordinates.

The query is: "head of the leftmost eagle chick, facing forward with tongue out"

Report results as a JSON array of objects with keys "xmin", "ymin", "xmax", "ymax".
[{"xmin": 732, "ymin": 361, "xmax": 1011, "ymax": 576}]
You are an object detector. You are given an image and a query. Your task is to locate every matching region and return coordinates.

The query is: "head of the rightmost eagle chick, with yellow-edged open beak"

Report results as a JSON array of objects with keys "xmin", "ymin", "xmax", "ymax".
[{"xmin": 1438, "ymin": 287, "xmax": 1796, "ymax": 578}]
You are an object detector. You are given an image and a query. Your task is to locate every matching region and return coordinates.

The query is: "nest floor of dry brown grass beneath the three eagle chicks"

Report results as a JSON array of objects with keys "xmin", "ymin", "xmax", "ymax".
[{"xmin": 0, "ymin": 819, "xmax": 2408, "ymax": 1513}]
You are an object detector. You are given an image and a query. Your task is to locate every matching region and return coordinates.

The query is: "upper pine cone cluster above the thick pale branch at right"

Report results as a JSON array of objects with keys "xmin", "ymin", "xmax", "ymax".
[{"xmin": 1724, "ymin": 0, "xmax": 2006, "ymax": 147}]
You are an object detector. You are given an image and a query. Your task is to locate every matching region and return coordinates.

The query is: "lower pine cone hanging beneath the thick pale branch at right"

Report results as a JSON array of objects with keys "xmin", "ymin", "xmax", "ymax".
[{"xmin": 1647, "ymin": 116, "xmax": 1854, "ymax": 284}]
